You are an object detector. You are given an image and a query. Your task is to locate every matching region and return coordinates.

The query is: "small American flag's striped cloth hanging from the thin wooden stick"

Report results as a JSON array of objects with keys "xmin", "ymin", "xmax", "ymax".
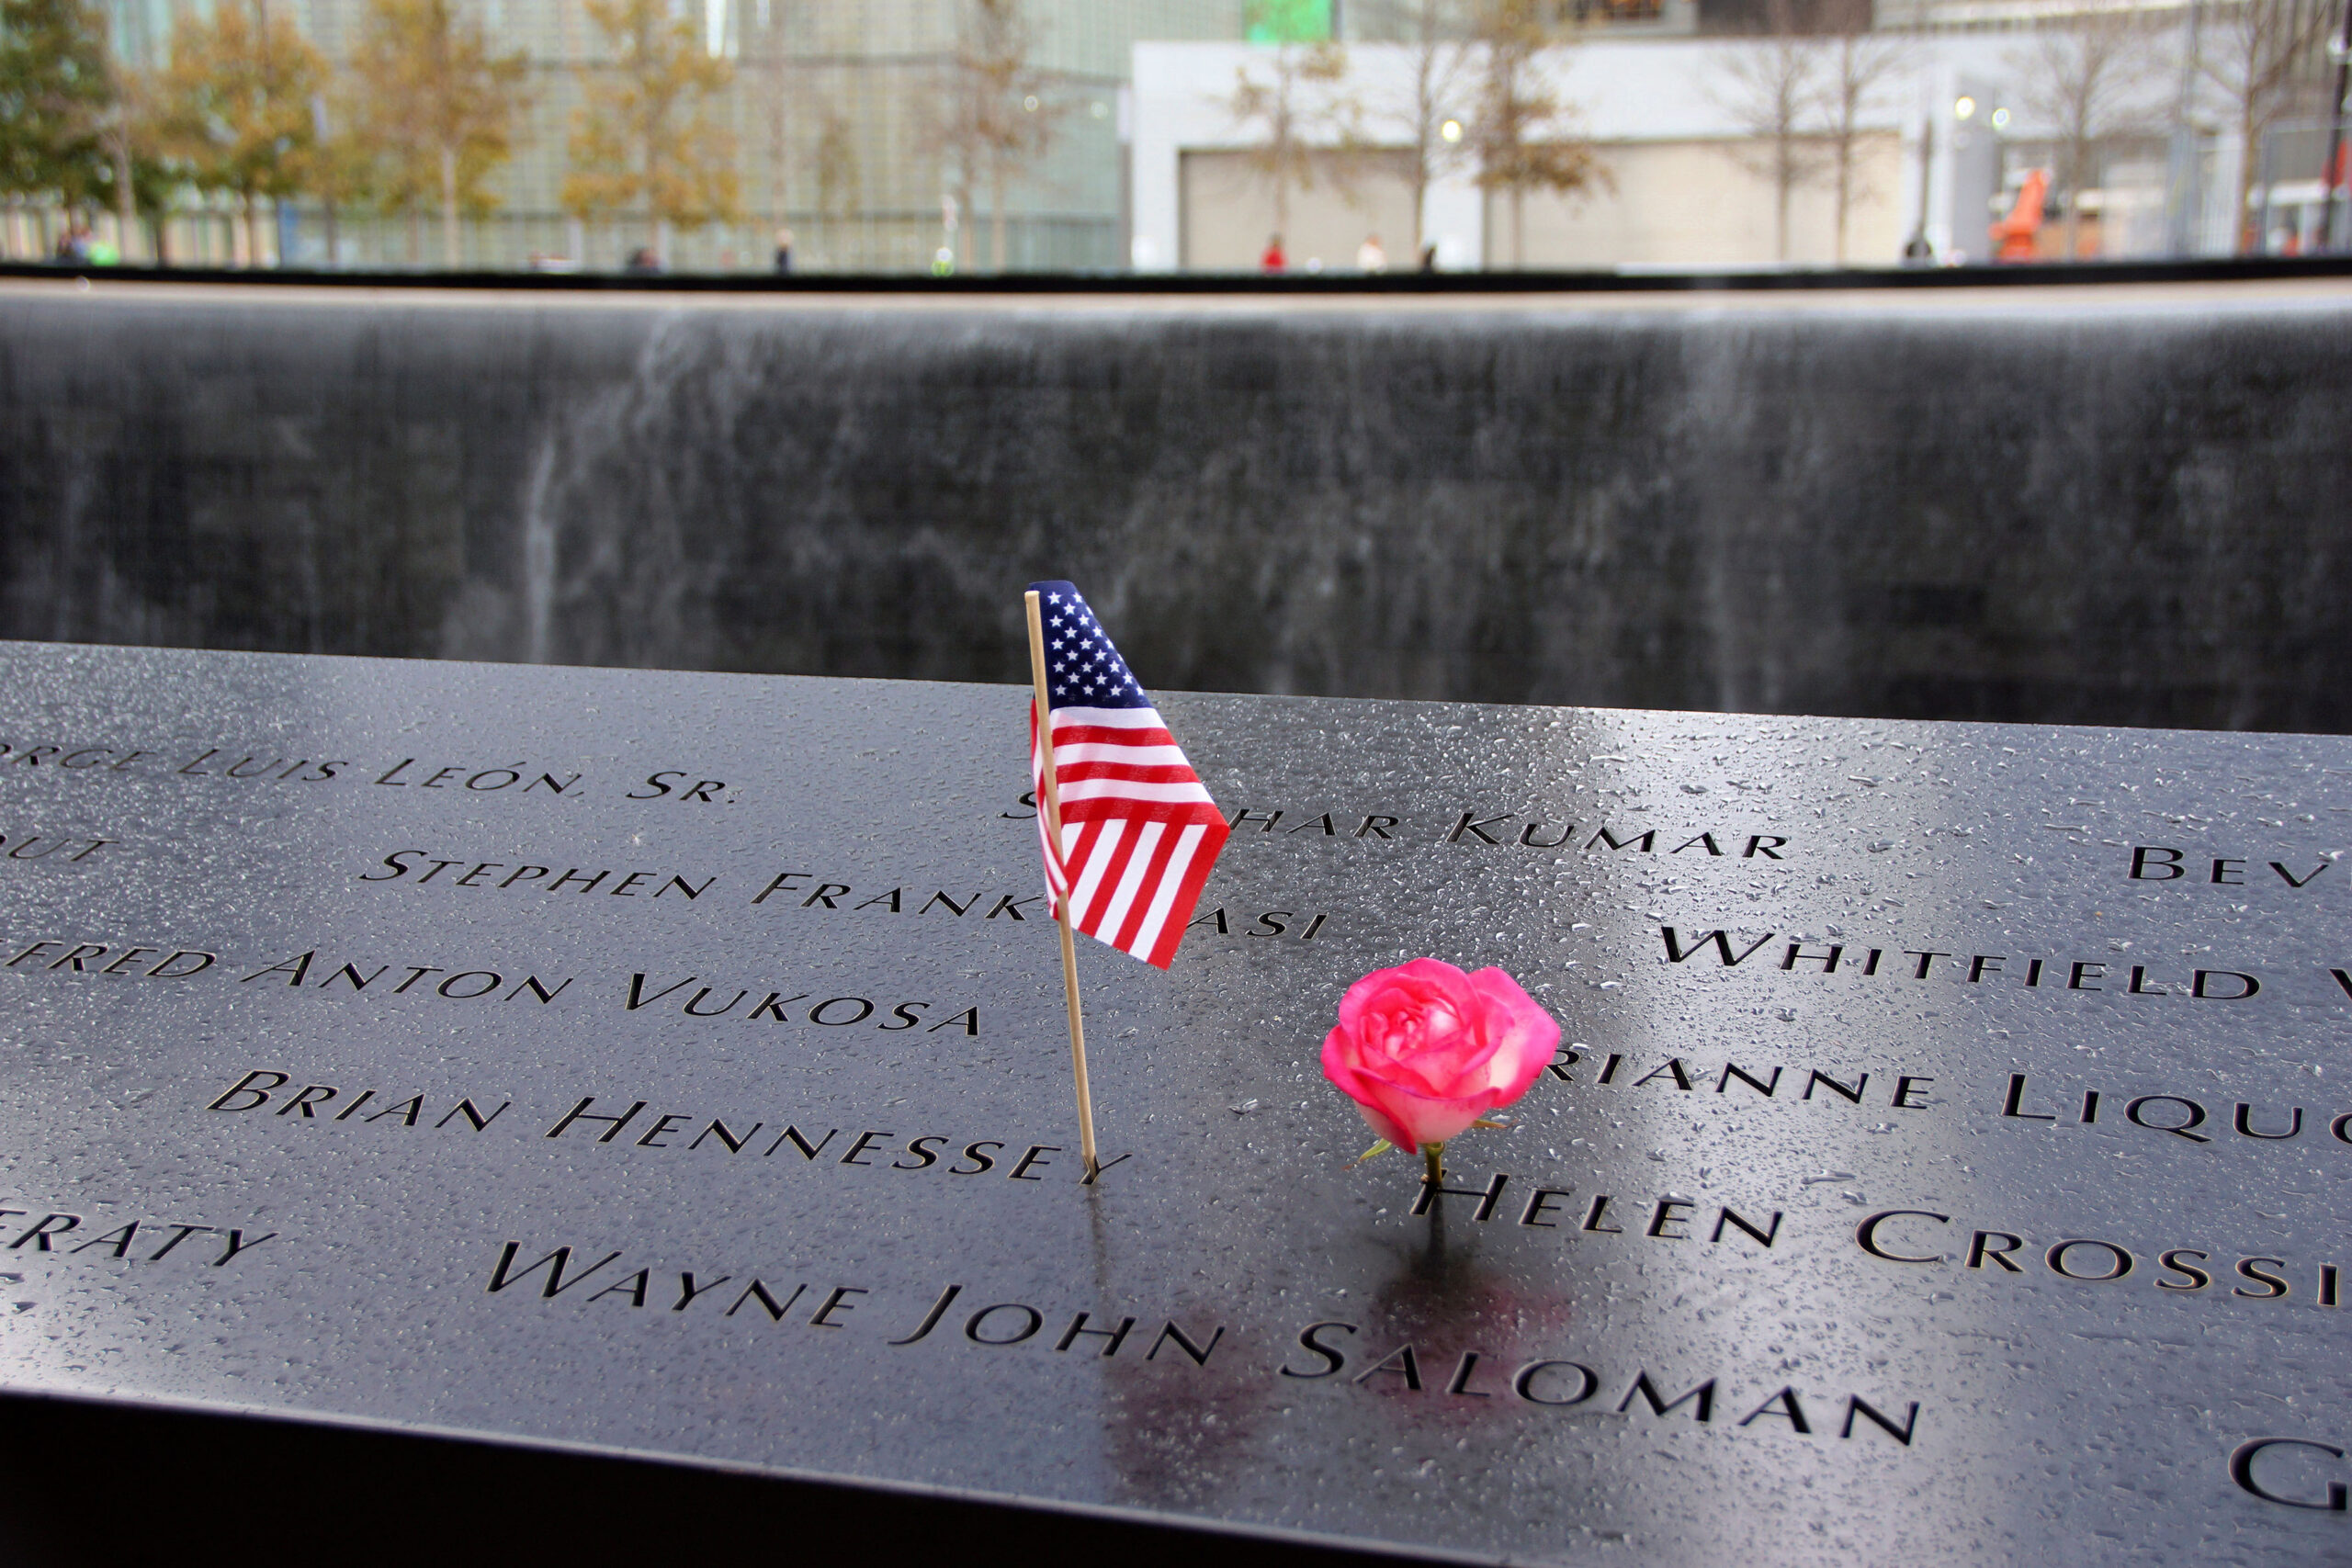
[{"xmin": 1030, "ymin": 583, "xmax": 1230, "ymax": 968}]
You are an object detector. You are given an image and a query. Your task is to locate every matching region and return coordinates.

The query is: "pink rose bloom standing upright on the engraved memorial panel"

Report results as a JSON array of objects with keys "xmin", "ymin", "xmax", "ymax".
[{"xmin": 1324, "ymin": 959, "xmax": 1559, "ymax": 1149}]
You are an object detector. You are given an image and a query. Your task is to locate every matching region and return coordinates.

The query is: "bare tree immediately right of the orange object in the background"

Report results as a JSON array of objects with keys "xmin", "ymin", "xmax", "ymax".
[{"xmin": 2011, "ymin": 0, "xmax": 2164, "ymax": 261}]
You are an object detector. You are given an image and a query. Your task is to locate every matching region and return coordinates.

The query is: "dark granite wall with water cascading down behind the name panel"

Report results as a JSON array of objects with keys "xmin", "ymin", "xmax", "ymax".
[{"xmin": 0, "ymin": 287, "xmax": 2352, "ymax": 731}]
